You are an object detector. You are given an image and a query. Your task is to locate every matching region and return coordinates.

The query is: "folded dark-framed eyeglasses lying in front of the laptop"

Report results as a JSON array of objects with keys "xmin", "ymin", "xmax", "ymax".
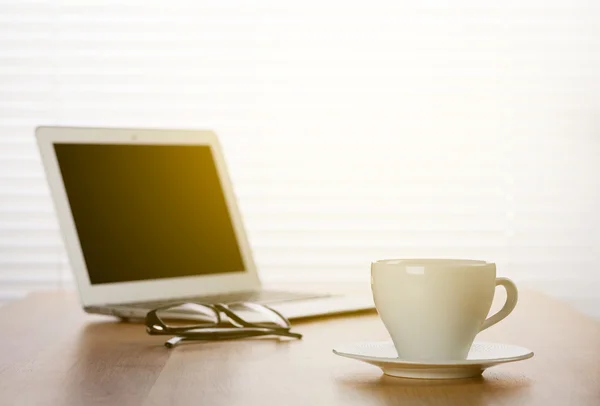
[{"xmin": 145, "ymin": 302, "xmax": 302, "ymax": 348}]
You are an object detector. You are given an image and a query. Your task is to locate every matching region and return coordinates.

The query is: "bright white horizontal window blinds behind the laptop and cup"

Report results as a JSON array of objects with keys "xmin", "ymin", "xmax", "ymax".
[{"xmin": 0, "ymin": 0, "xmax": 600, "ymax": 300}]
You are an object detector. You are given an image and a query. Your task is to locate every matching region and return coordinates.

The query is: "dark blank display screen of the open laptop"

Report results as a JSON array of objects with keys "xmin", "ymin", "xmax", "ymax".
[{"xmin": 54, "ymin": 143, "xmax": 245, "ymax": 285}]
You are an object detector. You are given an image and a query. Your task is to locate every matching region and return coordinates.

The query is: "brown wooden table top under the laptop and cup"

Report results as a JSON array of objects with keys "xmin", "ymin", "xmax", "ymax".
[{"xmin": 0, "ymin": 292, "xmax": 600, "ymax": 406}]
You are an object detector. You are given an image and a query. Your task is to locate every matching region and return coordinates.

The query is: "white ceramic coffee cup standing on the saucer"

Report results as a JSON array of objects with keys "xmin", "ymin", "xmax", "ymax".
[{"xmin": 371, "ymin": 259, "xmax": 518, "ymax": 362}]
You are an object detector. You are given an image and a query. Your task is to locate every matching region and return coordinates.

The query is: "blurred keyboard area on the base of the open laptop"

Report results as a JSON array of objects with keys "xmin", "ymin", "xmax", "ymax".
[{"xmin": 112, "ymin": 290, "xmax": 331, "ymax": 309}]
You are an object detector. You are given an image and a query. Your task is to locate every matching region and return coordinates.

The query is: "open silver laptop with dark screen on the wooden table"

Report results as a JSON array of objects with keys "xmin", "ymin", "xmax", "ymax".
[{"xmin": 36, "ymin": 127, "xmax": 374, "ymax": 320}]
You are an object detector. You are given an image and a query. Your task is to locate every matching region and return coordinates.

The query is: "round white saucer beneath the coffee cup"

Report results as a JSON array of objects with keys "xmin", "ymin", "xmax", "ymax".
[{"xmin": 333, "ymin": 341, "xmax": 533, "ymax": 379}]
